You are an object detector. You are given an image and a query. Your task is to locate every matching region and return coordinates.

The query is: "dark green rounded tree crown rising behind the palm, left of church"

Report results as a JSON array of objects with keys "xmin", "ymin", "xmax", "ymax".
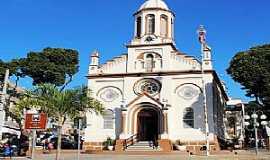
[{"xmin": 21, "ymin": 48, "xmax": 79, "ymax": 88}]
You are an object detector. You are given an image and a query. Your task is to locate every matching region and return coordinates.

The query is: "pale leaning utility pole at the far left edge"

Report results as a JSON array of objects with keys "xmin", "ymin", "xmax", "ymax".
[{"xmin": 0, "ymin": 69, "xmax": 9, "ymax": 140}]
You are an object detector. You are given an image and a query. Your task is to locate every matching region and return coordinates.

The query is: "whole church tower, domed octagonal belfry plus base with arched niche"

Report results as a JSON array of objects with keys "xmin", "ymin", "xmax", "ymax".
[{"xmin": 127, "ymin": 0, "xmax": 177, "ymax": 73}]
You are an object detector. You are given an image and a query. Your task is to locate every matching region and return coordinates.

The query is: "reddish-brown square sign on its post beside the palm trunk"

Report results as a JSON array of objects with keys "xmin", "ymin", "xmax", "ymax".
[{"xmin": 25, "ymin": 113, "xmax": 47, "ymax": 159}]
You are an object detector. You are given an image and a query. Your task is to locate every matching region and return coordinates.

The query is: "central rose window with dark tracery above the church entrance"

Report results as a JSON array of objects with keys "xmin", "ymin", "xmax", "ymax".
[{"xmin": 134, "ymin": 79, "xmax": 161, "ymax": 95}]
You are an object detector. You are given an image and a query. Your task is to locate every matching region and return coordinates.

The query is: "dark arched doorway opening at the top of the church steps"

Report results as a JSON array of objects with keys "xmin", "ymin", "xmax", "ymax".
[{"xmin": 137, "ymin": 108, "xmax": 159, "ymax": 141}]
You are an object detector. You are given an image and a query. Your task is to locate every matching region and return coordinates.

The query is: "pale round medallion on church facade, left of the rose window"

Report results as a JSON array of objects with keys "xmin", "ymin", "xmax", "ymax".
[{"xmin": 99, "ymin": 88, "xmax": 120, "ymax": 102}]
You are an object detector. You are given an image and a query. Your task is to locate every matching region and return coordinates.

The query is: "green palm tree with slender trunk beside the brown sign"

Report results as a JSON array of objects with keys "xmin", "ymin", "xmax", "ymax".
[{"xmin": 32, "ymin": 84, "xmax": 104, "ymax": 160}]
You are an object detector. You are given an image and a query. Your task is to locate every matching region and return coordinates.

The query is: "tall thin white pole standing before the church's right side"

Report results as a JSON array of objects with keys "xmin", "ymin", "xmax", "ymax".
[{"xmin": 197, "ymin": 25, "xmax": 210, "ymax": 156}]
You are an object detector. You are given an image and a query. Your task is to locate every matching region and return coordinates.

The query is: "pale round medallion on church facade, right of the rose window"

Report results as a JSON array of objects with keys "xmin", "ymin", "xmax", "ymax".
[{"xmin": 177, "ymin": 85, "xmax": 200, "ymax": 100}]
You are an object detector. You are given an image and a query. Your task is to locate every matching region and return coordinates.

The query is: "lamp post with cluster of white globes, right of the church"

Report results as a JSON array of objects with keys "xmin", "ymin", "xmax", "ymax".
[{"xmin": 245, "ymin": 110, "xmax": 268, "ymax": 155}]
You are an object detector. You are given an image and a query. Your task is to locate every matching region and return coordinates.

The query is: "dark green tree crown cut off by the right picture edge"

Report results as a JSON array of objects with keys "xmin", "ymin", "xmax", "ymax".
[{"xmin": 227, "ymin": 44, "xmax": 270, "ymax": 106}]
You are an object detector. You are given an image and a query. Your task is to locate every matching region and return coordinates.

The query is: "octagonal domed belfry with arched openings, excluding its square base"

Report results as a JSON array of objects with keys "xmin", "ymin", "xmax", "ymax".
[{"xmin": 132, "ymin": 0, "xmax": 175, "ymax": 44}]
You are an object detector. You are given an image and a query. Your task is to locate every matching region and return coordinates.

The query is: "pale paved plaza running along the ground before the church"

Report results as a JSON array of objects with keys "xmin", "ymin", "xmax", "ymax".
[{"xmin": 3, "ymin": 151, "xmax": 270, "ymax": 160}]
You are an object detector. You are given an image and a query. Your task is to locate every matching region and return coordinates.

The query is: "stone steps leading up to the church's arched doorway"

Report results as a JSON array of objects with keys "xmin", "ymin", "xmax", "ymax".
[{"xmin": 125, "ymin": 141, "xmax": 161, "ymax": 152}]
